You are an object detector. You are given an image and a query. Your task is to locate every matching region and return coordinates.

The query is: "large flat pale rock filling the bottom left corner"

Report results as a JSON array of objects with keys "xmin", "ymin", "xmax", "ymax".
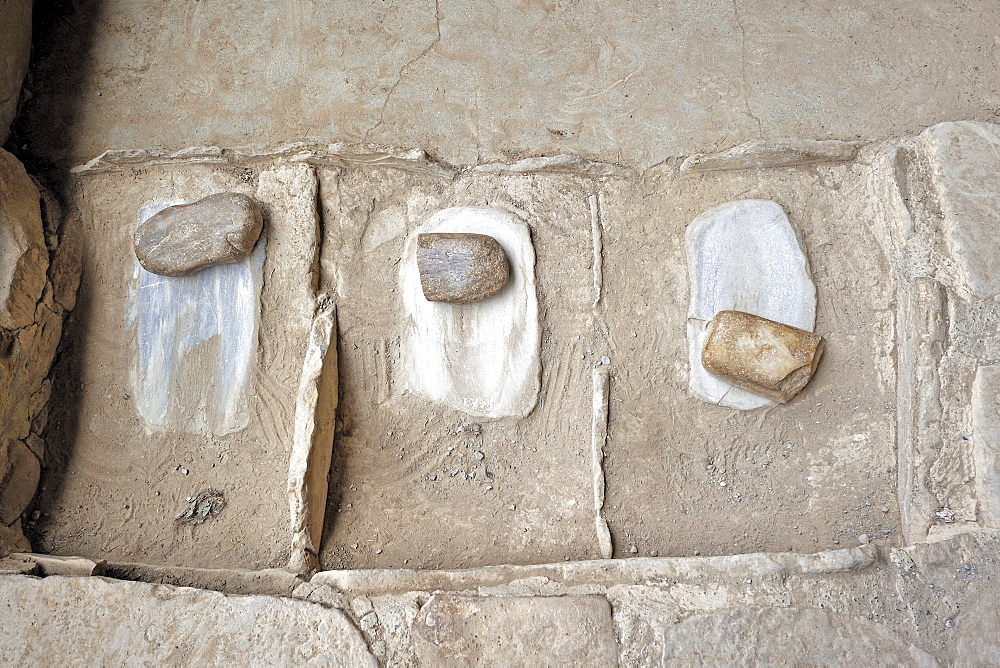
[{"xmin": 0, "ymin": 575, "xmax": 377, "ymax": 666}]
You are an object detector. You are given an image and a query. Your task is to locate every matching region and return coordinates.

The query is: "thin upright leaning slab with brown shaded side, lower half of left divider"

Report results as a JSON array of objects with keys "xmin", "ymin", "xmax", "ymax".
[{"xmin": 286, "ymin": 296, "xmax": 338, "ymax": 573}]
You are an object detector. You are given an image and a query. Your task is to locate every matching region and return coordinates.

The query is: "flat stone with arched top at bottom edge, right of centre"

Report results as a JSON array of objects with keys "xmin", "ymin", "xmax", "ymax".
[{"xmin": 660, "ymin": 608, "xmax": 934, "ymax": 666}]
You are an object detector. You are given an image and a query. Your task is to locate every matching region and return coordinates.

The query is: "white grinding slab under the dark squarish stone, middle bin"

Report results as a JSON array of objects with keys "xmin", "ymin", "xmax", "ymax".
[{"xmin": 400, "ymin": 207, "xmax": 541, "ymax": 418}]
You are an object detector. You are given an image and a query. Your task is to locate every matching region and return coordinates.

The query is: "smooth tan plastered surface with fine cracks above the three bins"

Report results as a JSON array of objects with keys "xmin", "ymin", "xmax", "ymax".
[{"xmin": 19, "ymin": 0, "xmax": 1000, "ymax": 166}]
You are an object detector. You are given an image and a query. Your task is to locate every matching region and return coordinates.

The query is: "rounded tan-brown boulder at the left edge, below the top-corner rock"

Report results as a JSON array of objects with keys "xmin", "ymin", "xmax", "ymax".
[{"xmin": 0, "ymin": 149, "xmax": 49, "ymax": 329}]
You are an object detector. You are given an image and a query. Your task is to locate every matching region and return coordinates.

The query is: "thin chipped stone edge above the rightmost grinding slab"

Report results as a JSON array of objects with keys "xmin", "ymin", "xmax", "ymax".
[{"xmin": 680, "ymin": 138, "xmax": 864, "ymax": 172}]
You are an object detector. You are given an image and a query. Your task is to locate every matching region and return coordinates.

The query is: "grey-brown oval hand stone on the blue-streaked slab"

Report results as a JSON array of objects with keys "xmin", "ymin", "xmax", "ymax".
[{"xmin": 135, "ymin": 193, "xmax": 263, "ymax": 276}]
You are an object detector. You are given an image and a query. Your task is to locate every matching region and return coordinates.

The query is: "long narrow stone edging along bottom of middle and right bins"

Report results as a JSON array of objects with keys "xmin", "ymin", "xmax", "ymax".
[{"xmin": 310, "ymin": 544, "xmax": 878, "ymax": 595}]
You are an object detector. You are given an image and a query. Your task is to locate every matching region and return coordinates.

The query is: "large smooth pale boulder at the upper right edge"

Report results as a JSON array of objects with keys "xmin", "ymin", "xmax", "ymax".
[{"xmin": 920, "ymin": 121, "xmax": 1000, "ymax": 297}]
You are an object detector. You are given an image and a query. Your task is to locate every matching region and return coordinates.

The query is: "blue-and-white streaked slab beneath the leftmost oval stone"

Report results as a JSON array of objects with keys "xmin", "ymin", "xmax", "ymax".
[{"xmin": 127, "ymin": 202, "xmax": 265, "ymax": 436}]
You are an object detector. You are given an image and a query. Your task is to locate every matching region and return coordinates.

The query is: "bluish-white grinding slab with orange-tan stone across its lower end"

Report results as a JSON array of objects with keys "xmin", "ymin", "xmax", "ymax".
[{"xmin": 685, "ymin": 200, "xmax": 816, "ymax": 410}]
